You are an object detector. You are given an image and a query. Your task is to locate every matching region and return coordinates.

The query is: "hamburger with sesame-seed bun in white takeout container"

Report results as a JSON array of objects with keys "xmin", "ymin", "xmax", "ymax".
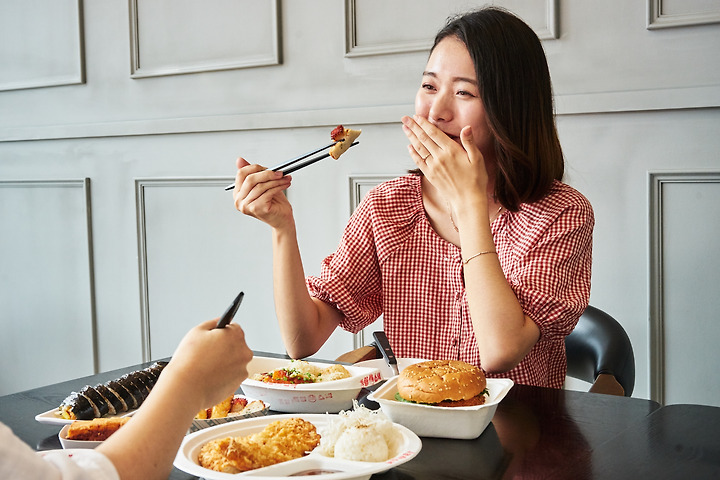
[{"xmin": 395, "ymin": 360, "xmax": 488, "ymax": 407}]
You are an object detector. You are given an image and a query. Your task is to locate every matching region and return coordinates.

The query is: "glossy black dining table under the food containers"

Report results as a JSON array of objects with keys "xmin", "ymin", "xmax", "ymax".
[{"xmin": 0, "ymin": 352, "xmax": 720, "ymax": 480}]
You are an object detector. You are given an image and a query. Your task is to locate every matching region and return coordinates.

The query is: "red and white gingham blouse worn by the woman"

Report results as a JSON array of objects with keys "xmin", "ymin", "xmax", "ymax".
[{"xmin": 306, "ymin": 175, "xmax": 595, "ymax": 388}]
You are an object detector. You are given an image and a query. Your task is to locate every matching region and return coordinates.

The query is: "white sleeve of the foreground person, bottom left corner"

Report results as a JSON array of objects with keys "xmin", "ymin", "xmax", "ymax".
[{"xmin": 0, "ymin": 423, "xmax": 120, "ymax": 480}]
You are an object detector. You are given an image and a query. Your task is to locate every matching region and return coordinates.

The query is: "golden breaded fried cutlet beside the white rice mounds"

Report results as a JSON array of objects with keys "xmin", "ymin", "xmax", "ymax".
[{"xmin": 198, "ymin": 418, "xmax": 320, "ymax": 473}]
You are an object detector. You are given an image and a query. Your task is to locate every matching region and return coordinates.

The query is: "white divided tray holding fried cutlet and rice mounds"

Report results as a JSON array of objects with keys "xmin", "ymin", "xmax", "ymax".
[{"xmin": 174, "ymin": 414, "xmax": 422, "ymax": 480}]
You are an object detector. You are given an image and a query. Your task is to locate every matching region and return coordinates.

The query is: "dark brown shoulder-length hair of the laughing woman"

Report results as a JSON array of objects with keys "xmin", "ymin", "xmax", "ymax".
[{"xmin": 416, "ymin": 7, "xmax": 565, "ymax": 211}]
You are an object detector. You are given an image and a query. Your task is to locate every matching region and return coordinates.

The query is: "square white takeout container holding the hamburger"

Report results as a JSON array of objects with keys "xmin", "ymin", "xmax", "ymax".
[{"xmin": 368, "ymin": 377, "xmax": 514, "ymax": 440}]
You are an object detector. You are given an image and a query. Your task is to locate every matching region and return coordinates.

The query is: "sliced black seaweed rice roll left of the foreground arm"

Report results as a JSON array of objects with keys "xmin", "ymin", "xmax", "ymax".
[{"xmin": 59, "ymin": 362, "xmax": 167, "ymax": 420}]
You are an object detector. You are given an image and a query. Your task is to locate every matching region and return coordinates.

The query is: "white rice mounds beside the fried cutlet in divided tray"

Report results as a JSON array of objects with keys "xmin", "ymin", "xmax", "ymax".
[{"xmin": 318, "ymin": 401, "xmax": 403, "ymax": 462}]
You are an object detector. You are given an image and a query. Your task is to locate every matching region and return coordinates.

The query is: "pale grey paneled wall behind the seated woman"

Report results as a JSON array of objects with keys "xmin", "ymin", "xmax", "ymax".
[{"xmin": 0, "ymin": 0, "xmax": 720, "ymax": 403}]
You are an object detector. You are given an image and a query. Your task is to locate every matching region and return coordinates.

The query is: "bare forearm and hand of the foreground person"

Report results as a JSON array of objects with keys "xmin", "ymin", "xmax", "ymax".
[{"xmin": 97, "ymin": 319, "xmax": 252, "ymax": 479}]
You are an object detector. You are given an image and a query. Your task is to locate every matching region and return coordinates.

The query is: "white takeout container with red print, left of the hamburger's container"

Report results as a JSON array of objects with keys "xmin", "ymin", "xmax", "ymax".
[{"xmin": 240, "ymin": 357, "xmax": 382, "ymax": 413}]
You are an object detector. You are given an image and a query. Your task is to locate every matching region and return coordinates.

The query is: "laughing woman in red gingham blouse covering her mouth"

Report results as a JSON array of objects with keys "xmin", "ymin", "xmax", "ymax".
[{"xmin": 234, "ymin": 7, "xmax": 594, "ymax": 388}]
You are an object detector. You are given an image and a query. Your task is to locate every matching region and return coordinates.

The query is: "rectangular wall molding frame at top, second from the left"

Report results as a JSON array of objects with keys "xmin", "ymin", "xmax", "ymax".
[{"xmin": 129, "ymin": 0, "xmax": 280, "ymax": 78}]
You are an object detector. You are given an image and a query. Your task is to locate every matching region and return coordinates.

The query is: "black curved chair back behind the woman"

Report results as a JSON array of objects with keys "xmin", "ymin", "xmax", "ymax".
[{"xmin": 565, "ymin": 306, "xmax": 635, "ymax": 397}]
